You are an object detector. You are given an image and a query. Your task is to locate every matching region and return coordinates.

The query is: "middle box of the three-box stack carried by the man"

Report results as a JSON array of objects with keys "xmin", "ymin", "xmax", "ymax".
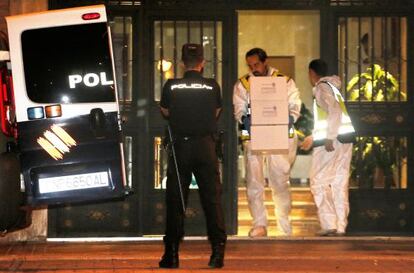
[{"xmin": 250, "ymin": 100, "xmax": 289, "ymax": 125}]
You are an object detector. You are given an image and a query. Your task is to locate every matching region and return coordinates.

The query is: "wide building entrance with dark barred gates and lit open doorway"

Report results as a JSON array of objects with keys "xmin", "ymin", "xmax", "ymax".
[{"xmin": 42, "ymin": 0, "xmax": 414, "ymax": 237}]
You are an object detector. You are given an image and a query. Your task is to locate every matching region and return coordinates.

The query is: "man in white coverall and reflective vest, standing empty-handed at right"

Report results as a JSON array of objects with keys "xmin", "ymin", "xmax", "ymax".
[{"xmin": 301, "ymin": 59, "xmax": 355, "ymax": 236}]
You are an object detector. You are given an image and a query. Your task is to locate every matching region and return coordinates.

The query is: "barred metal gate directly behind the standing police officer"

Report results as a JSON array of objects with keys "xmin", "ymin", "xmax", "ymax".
[{"xmin": 144, "ymin": 13, "xmax": 237, "ymax": 235}]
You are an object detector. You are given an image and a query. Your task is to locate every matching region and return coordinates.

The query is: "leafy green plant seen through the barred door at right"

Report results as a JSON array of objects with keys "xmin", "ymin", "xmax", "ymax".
[{"xmin": 346, "ymin": 64, "xmax": 407, "ymax": 188}]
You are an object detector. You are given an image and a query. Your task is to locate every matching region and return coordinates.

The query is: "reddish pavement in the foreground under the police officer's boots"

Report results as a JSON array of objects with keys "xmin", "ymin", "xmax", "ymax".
[{"xmin": 0, "ymin": 237, "xmax": 414, "ymax": 273}]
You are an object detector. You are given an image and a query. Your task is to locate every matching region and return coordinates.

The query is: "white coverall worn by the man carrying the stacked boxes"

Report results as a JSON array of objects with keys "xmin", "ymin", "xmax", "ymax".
[{"xmin": 233, "ymin": 67, "xmax": 302, "ymax": 235}]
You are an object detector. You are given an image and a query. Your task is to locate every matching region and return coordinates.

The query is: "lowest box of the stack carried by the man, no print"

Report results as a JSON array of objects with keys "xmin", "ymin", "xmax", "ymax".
[{"xmin": 250, "ymin": 125, "xmax": 289, "ymax": 154}]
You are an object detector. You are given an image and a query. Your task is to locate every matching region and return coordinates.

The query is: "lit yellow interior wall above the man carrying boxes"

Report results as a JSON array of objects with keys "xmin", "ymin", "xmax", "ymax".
[{"xmin": 238, "ymin": 10, "xmax": 320, "ymax": 109}]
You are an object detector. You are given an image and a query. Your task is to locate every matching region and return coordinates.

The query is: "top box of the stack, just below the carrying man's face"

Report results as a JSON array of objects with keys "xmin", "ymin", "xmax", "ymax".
[{"xmin": 249, "ymin": 77, "xmax": 288, "ymax": 102}]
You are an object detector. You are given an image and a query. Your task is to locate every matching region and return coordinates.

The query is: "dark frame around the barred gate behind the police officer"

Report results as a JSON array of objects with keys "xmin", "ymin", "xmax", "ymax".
[{"xmin": 138, "ymin": 9, "xmax": 237, "ymax": 235}]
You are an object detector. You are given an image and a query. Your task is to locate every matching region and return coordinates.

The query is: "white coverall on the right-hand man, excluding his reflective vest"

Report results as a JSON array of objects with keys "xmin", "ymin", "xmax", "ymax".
[{"xmin": 309, "ymin": 76, "xmax": 352, "ymax": 233}]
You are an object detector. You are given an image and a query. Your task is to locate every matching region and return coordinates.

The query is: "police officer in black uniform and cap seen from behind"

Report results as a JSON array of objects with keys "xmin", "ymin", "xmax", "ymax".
[{"xmin": 159, "ymin": 44, "xmax": 226, "ymax": 268}]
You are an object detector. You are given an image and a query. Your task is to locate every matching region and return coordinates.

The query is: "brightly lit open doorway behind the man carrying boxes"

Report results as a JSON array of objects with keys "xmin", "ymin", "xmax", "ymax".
[{"xmin": 234, "ymin": 10, "xmax": 320, "ymax": 236}]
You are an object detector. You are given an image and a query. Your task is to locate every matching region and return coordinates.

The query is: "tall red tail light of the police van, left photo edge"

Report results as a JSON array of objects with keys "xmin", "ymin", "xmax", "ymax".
[{"xmin": 0, "ymin": 66, "xmax": 17, "ymax": 138}]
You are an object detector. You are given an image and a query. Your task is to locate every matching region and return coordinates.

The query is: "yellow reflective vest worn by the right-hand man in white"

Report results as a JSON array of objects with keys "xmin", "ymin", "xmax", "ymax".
[{"xmin": 313, "ymin": 81, "xmax": 356, "ymax": 147}]
